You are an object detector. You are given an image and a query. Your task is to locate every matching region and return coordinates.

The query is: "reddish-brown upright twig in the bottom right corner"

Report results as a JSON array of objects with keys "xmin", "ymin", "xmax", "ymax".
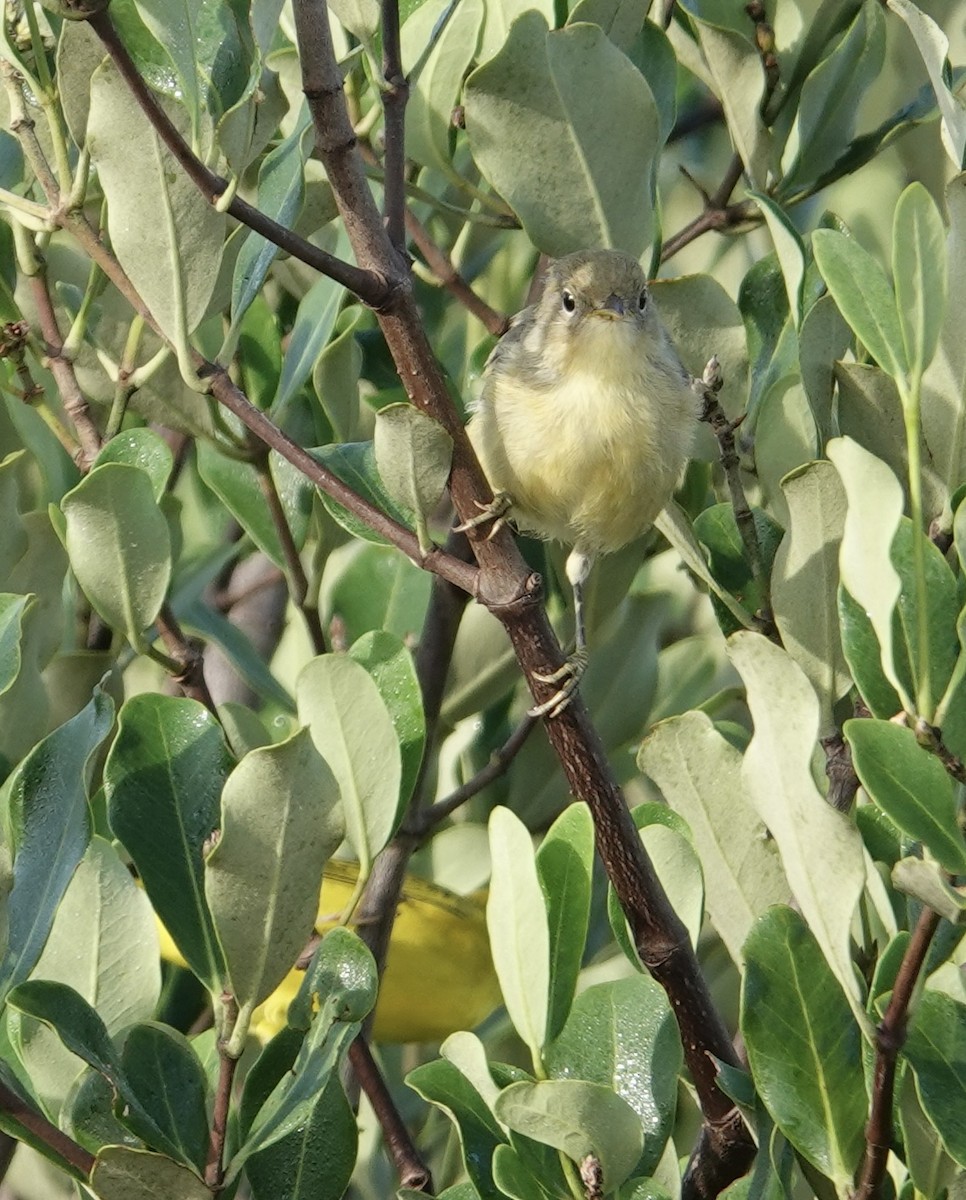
[{"xmin": 853, "ymin": 908, "xmax": 940, "ymax": 1200}]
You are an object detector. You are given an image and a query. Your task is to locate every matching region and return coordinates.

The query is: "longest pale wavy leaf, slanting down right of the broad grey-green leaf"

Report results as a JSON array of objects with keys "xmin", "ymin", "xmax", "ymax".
[{"xmin": 730, "ymin": 632, "xmax": 865, "ymax": 1022}]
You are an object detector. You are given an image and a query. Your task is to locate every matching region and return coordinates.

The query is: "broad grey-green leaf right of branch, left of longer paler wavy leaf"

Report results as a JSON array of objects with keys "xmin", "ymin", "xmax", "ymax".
[{"xmin": 637, "ymin": 713, "xmax": 788, "ymax": 962}]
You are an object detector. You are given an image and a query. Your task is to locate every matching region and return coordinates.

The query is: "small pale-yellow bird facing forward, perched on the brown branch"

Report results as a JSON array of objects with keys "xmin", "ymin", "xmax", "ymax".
[{"xmin": 460, "ymin": 250, "xmax": 700, "ymax": 716}]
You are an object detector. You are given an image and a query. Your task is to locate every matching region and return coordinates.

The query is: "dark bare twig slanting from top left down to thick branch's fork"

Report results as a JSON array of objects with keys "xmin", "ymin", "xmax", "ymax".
[{"xmin": 88, "ymin": 10, "xmax": 390, "ymax": 308}]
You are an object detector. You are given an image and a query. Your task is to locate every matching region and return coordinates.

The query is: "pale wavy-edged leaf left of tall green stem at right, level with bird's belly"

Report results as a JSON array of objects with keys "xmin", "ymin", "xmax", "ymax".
[{"xmin": 828, "ymin": 438, "xmax": 912, "ymax": 709}]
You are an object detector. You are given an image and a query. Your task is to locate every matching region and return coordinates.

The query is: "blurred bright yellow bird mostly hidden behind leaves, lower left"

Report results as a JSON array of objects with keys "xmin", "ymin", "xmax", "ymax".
[{"xmin": 158, "ymin": 862, "xmax": 500, "ymax": 1042}]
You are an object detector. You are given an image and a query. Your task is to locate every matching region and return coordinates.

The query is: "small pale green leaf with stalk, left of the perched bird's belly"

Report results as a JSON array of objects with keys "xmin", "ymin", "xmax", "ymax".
[{"xmin": 372, "ymin": 404, "xmax": 452, "ymax": 553}]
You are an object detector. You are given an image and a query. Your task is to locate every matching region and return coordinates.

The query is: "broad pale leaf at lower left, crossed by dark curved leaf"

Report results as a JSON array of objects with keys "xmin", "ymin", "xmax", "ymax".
[{"xmin": 10, "ymin": 836, "xmax": 161, "ymax": 1117}]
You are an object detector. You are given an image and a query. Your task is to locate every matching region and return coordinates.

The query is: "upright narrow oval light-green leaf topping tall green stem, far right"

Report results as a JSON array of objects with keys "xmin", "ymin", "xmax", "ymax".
[{"xmin": 893, "ymin": 184, "xmax": 946, "ymax": 379}]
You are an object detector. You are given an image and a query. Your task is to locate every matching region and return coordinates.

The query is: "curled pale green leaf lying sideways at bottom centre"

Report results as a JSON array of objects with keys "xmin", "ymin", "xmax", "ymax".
[{"xmin": 497, "ymin": 1079, "xmax": 643, "ymax": 1193}]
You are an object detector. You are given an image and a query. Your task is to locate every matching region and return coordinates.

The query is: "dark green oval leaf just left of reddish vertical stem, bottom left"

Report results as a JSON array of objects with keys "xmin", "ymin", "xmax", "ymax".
[{"xmin": 121, "ymin": 1021, "xmax": 209, "ymax": 1174}]
